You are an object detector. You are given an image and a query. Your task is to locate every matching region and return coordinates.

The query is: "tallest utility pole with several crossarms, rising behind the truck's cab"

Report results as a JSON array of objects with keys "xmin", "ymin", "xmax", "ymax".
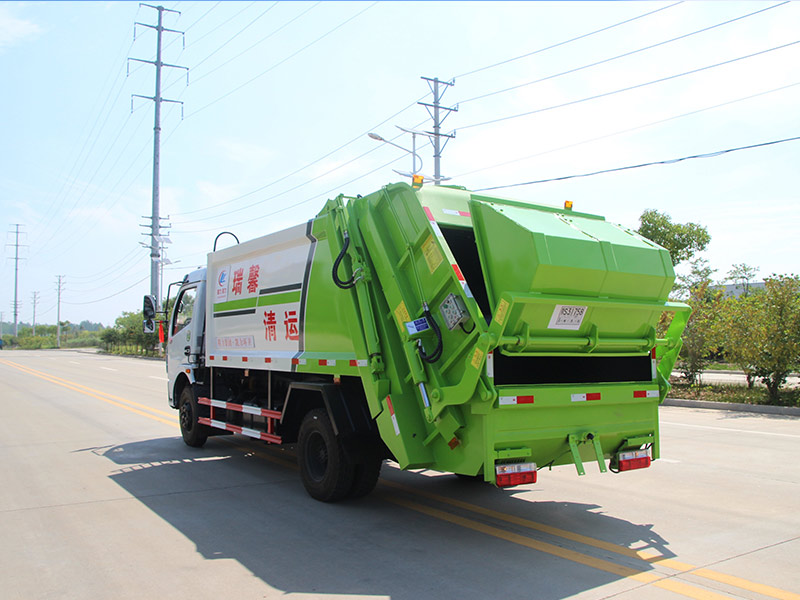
[{"xmin": 128, "ymin": 3, "xmax": 189, "ymax": 306}]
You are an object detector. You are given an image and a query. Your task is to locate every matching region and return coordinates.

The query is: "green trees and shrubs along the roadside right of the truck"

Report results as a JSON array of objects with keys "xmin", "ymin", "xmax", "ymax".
[{"xmin": 638, "ymin": 210, "xmax": 800, "ymax": 406}]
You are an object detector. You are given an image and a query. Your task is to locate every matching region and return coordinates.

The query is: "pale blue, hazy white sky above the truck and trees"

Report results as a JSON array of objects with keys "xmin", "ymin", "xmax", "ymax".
[{"xmin": 0, "ymin": 1, "xmax": 800, "ymax": 325}]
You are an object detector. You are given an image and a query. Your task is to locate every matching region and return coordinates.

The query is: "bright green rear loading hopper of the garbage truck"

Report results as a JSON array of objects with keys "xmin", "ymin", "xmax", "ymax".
[{"xmin": 348, "ymin": 185, "xmax": 688, "ymax": 482}]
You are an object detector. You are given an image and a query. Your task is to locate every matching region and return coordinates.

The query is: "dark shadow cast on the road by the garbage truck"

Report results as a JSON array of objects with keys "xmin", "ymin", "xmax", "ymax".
[{"xmin": 98, "ymin": 437, "xmax": 669, "ymax": 600}]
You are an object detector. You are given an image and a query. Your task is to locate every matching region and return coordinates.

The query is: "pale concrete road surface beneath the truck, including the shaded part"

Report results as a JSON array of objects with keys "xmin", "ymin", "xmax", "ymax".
[{"xmin": 0, "ymin": 351, "xmax": 800, "ymax": 600}]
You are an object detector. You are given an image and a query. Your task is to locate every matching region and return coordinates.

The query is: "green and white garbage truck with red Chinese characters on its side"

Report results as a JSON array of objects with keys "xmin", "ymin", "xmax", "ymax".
[{"xmin": 144, "ymin": 181, "xmax": 690, "ymax": 502}]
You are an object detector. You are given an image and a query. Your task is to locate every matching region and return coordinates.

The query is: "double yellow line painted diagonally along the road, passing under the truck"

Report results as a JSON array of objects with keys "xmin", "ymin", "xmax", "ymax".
[{"xmin": 0, "ymin": 359, "xmax": 800, "ymax": 600}]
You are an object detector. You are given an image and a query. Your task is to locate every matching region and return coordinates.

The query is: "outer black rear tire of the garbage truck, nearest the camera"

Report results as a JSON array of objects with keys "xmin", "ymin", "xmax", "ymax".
[{"xmin": 297, "ymin": 408, "xmax": 354, "ymax": 502}]
